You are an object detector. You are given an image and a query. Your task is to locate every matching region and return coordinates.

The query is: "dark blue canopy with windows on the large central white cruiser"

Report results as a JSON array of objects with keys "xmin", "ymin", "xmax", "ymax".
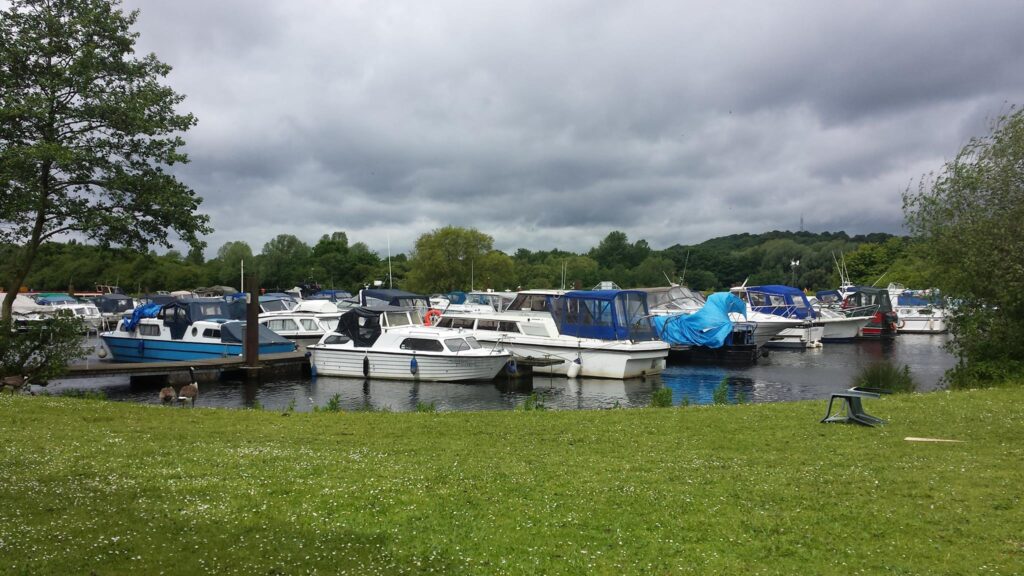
[{"xmin": 550, "ymin": 290, "xmax": 657, "ymax": 341}]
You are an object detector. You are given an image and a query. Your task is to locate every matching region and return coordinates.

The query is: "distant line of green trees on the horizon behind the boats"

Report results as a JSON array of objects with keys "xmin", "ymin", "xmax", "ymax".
[{"xmin": 0, "ymin": 227, "xmax": 934, "ymax": 293}]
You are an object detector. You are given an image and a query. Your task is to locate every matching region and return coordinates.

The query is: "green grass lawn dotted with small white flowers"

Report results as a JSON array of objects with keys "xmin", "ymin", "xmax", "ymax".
[{"xmin": 0, "ymin": 387, "xmax": 1024, "ymax": 575}]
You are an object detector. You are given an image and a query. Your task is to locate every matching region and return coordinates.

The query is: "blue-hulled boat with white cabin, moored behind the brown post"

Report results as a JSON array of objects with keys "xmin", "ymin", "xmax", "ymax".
[{"xmin": 99, "ymin": 298, "xmax": 295, "ymax": 362}]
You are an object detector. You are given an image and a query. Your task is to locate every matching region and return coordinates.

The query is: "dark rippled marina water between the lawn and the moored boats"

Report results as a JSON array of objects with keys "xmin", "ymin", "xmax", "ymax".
[{"xmin": 46, "ymin": 334, "xmax": 955, "ymax": 411}]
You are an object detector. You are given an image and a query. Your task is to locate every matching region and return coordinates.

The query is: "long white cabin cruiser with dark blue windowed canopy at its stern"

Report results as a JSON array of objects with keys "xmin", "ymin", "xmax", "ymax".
[{"xmin": 437, "ymin": 290, "xmax": 669, "ymax": 379}]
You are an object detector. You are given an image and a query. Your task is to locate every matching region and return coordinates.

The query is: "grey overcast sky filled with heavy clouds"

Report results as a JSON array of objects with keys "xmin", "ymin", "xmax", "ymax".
[{"xmin": 125, "ymin": 0, "xmax": 1024, "ymax": 255}]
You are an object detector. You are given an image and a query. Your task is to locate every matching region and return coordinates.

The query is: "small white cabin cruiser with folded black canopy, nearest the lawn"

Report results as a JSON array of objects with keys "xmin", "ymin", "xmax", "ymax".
[{"xmin": 307, "ymin": 304, "xmax": 511, "ymax": 381}]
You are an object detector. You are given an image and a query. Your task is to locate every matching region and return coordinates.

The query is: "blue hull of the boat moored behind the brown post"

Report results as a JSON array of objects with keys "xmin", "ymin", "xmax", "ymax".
[{"xmin": 100, "ymin": 334, "xmax": 295, "ymax": 362}]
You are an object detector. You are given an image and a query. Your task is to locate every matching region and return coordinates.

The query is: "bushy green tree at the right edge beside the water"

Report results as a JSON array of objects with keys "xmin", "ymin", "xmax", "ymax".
[{"xmin": 903, "ymin": 109, "xmax": 1024, "ymax": 385}]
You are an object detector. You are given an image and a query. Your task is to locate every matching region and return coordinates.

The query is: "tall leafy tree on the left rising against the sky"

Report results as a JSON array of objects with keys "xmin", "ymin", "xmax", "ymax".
[{"xmin": 0, "ymin": 0, "xmax": 210, "ymax": 322}]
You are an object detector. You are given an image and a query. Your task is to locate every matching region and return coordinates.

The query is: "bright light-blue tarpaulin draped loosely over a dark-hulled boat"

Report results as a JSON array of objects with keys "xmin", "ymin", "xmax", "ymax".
[{"xmin": 652, "ymin": 292, "xmax": 746, "ymax": 348}]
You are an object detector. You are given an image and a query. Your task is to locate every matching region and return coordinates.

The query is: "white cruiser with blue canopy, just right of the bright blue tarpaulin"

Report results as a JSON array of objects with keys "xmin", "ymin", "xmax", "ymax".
[{"xmin": 729, "ymin": 285, "xmax": 824, "ymax": 348}]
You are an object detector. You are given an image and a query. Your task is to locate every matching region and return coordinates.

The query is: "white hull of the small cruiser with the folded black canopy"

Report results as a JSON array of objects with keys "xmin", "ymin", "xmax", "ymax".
[{"xmin": 308, "ymin": 346, "xmax": 510, "ymax": 382}]
